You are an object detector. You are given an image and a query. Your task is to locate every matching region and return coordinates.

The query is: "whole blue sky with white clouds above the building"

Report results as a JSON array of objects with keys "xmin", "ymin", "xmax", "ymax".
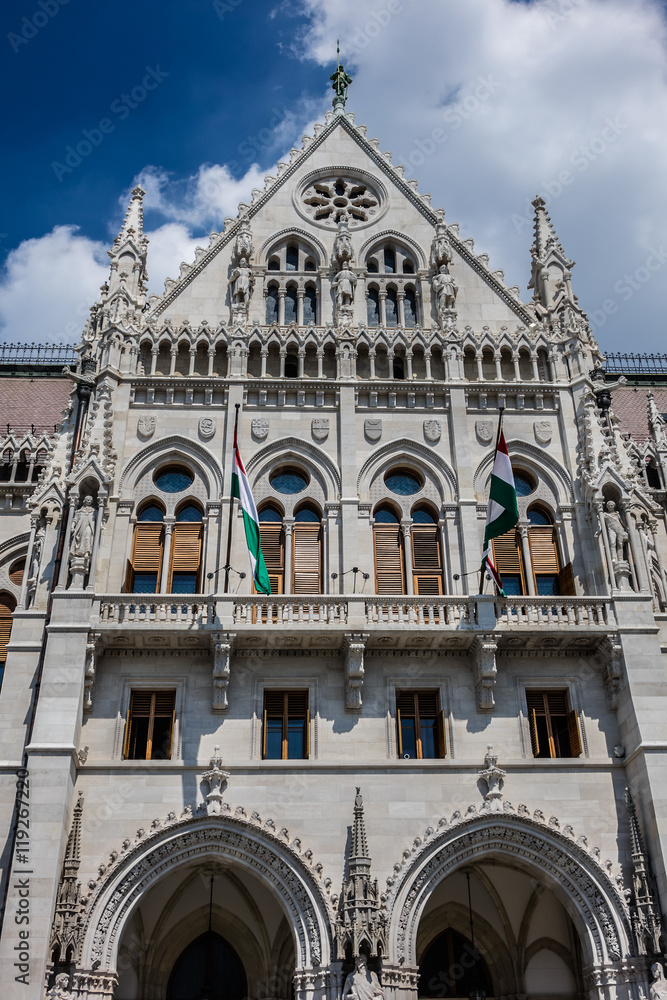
[{"xmin": 0, "ymin": 0, "xmax": 667, "ymax": 352}]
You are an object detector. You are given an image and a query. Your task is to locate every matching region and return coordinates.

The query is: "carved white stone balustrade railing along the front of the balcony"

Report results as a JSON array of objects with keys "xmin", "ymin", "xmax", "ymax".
[{"xmin": 94, "ymin": 594, "xmax": 616, "ymax": 631}]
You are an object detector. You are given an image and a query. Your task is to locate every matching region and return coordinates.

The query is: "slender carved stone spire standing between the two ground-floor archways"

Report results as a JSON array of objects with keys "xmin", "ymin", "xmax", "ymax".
[{"xmin": 336, "ymin": 788, "xmax": 386, "ymax": 958}]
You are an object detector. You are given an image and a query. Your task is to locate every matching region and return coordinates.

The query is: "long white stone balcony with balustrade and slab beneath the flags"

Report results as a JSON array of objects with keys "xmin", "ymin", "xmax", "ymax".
[{"xmin": 91, "ymin": 594, "xmax": 617, "ymax": 651}]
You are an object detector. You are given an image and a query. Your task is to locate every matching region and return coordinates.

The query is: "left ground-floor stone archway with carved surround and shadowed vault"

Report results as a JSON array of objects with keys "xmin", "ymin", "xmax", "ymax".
[{"xmin": 74, "ymin": 816, "xmax": 332, "ymax": 1000}]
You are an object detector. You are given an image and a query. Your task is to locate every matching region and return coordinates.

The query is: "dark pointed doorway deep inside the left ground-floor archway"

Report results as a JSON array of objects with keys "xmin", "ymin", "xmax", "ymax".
[{"xmin": 167, "ymin": 931, "xmax": 248, "ymax": 1000}]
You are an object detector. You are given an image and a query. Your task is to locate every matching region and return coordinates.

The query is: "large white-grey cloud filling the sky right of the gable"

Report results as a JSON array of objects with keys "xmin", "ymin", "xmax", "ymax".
[{"xmin": 295, "ymin": 0, "xmax": 667, "ymax": 351}]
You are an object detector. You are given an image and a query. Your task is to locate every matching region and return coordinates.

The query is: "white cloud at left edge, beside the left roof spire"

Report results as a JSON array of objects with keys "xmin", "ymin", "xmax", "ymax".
[{"xmin": 0, "ymin": 226, "xmax": 109, "ymax": 343}]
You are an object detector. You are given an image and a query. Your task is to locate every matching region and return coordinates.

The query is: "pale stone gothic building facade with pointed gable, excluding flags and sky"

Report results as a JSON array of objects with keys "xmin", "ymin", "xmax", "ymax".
[{"xmin": 0, "ymin": 86, "xmax": 667, "ymax": 1000}]
